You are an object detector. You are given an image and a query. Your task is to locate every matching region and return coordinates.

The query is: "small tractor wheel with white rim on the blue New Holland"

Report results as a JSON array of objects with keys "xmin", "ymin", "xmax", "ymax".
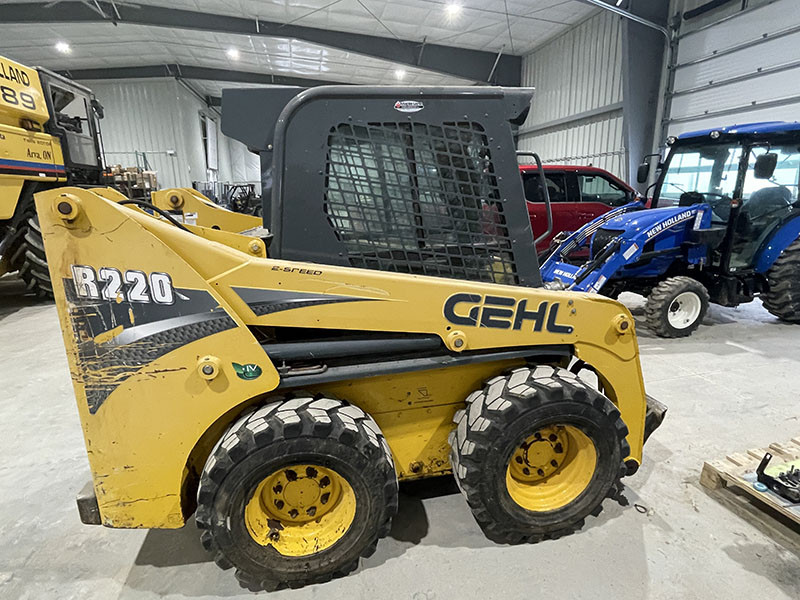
[{"xmin": 645, "ymin": 275, "xmax": 709, "ymax": 338}]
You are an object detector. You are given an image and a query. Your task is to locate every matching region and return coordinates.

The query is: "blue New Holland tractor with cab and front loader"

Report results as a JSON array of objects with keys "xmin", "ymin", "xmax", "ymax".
[{"xmin": 542, "ymin": 122, "xmax": 800, "ymax": 337}]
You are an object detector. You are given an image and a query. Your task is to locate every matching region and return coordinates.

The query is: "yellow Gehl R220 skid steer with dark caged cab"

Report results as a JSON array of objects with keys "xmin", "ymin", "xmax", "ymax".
[{"xmin": 36, "ymin": 87, "xmax": 664, "ymax": 589}]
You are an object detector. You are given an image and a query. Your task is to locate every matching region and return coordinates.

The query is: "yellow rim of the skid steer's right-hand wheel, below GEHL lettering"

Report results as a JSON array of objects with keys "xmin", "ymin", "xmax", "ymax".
[{"xmin": 506, "ymin": 425, "xmax": 597, "ymax": 512}]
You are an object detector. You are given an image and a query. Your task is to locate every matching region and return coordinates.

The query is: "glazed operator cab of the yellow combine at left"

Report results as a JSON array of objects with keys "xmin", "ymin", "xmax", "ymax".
[{"xmin": 38, "ymin": 67, "xmax": 103, "ymax": 183}]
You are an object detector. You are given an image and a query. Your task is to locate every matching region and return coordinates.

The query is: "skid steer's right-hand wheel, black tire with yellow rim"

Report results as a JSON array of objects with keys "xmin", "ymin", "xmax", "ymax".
[{"xmin": 450, "ymin": 366, "xmax": 630, "ymax": 543}]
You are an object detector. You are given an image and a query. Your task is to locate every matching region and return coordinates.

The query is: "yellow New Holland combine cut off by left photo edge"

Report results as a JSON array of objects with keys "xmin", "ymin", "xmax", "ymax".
[{"xmin": 0, "ymin": 56, "xmax": 103, "ymax": 296}]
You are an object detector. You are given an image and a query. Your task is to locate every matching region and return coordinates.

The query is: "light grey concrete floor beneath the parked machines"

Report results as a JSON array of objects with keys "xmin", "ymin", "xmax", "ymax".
[{"xmin": 0, "ymin": 280, "xmax": 800, "ymax": 600}]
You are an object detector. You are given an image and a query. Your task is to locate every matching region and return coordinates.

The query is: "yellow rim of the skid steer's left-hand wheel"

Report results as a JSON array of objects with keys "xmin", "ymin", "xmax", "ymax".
[{"xmin": 244, "ymin": 464, "xmax": 356, "ymax": 556}]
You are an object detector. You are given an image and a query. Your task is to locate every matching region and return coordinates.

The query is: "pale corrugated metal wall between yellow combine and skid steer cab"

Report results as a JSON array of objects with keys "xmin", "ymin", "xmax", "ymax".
[{"xmin": 85, "ymin": 79, "xmax": 260, "ymax": 188}]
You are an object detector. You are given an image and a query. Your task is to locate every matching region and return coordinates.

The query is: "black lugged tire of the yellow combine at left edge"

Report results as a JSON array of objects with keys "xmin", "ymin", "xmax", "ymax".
[{"xmin": 8, "ymin": 188, "xmax": 53, "ymax": 299}]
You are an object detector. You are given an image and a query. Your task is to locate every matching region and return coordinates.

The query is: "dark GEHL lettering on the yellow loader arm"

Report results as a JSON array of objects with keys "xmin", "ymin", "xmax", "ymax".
[{"xmin": 444, "ymin": 293, "xmax": 573, "ymax": 334}]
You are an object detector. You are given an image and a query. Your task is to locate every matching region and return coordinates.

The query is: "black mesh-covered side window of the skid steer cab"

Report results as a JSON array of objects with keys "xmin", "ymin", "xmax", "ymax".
[{"xmin": 325, "ymin": 122, "xmax": 518, "ymax": 283}]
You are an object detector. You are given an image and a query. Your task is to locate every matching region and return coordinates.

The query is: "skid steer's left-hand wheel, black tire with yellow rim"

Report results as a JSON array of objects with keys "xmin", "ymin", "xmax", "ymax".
[{"xmin": 197, "ymin": 394, "xmax": 397, "ymax": 591}]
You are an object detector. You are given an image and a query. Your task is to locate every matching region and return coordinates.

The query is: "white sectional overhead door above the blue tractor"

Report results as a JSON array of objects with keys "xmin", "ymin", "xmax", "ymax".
[{"xmin": 668, "ymin": 0, "xmax": 800, "ymax": 135}]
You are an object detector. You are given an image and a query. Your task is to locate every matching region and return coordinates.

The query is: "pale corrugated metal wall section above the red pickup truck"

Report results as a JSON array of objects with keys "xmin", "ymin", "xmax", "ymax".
[{"xmin": 519, "ymin": 12, "xmax": 627, "ymax": 178}]
